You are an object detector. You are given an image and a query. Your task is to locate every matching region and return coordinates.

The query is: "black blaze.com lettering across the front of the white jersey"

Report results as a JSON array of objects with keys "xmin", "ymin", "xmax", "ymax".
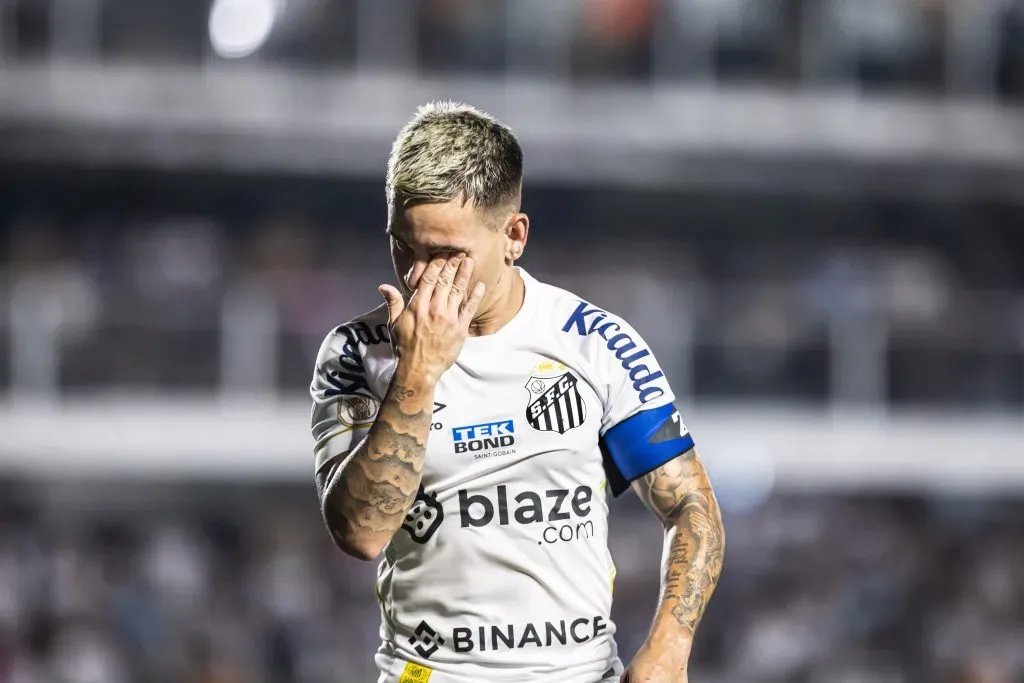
[{"xmin": 459, "ymin": 484, "xmax": 596, "ymax": 546}]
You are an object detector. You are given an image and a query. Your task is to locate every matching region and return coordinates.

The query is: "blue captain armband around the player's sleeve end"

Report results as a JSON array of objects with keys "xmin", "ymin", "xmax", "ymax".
[{"xmin": 600, "ymin": 403, "xmax": 693, "ymax": 496}]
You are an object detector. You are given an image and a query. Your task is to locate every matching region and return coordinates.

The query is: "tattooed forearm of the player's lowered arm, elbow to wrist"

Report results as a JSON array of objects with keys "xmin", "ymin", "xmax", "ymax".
[{"xmin": 653, "ymin": 490, "xmax": 725, "ymax": 642}]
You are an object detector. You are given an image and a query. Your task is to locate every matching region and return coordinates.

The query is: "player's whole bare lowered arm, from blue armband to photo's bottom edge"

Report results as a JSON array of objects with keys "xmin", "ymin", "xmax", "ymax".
[{"xmin": 627, "ymin": 449, "xmax": 725, "ymax": 681}]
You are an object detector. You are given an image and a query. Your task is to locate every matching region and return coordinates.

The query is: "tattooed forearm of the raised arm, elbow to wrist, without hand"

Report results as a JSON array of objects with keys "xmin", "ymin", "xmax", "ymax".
[{"xmin": 322, "ymin": 364, "xmax": 434, "ymax": 559}]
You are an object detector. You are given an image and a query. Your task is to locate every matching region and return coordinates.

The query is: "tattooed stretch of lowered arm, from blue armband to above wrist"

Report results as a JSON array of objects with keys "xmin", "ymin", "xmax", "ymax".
[{"xmin": 635, "ymin": 450, "xmax": 725, "ymax": 634}]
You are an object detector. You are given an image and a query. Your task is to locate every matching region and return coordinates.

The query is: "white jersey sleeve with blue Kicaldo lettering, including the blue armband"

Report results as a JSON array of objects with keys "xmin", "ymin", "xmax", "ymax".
[{"xmin": 565, "ymin": 303, "xmax": 693, "ymax": 496}]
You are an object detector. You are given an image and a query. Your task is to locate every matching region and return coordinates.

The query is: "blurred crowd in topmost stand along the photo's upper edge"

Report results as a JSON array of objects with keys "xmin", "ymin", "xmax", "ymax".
[{"xmin": 0, "ymin": 0, "xmax": 1024, "ymax": 98}]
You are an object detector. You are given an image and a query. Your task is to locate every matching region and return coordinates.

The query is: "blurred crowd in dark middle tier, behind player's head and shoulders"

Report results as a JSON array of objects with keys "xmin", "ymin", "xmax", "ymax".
[{"xmin": 0, "ymin": 172, "xmax": 1024, "ymax": 410}]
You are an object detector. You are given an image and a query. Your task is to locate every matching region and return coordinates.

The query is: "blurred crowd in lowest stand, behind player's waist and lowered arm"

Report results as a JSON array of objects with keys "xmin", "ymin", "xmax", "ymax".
[{"xmin": 0, "ymin": 481, "xmax": 1024, "ymax": 683}]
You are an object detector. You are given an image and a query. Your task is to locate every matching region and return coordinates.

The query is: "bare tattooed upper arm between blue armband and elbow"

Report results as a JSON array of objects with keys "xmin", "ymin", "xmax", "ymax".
[{"xmin": 633, "ymin": 449, "xmax": 715, "ymax": 524}]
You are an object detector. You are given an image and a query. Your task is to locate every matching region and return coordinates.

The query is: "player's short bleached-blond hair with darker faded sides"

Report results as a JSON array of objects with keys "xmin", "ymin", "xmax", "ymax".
[{"xmin": 385, "ymin": 101, "xmax": 522, "ymax": 220}]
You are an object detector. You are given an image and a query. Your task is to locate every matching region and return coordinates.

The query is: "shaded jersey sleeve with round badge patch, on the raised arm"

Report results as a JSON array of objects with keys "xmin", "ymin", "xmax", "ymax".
[{"xmin": 309, "ymin": 326, "xmax": 381, "ymax": 485}]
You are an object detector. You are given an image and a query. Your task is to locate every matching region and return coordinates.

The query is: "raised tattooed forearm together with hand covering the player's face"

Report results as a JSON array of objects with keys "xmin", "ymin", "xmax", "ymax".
[{"xmin": 316, "ymin": 253, "xmax": 485, "ymax": 560}]
